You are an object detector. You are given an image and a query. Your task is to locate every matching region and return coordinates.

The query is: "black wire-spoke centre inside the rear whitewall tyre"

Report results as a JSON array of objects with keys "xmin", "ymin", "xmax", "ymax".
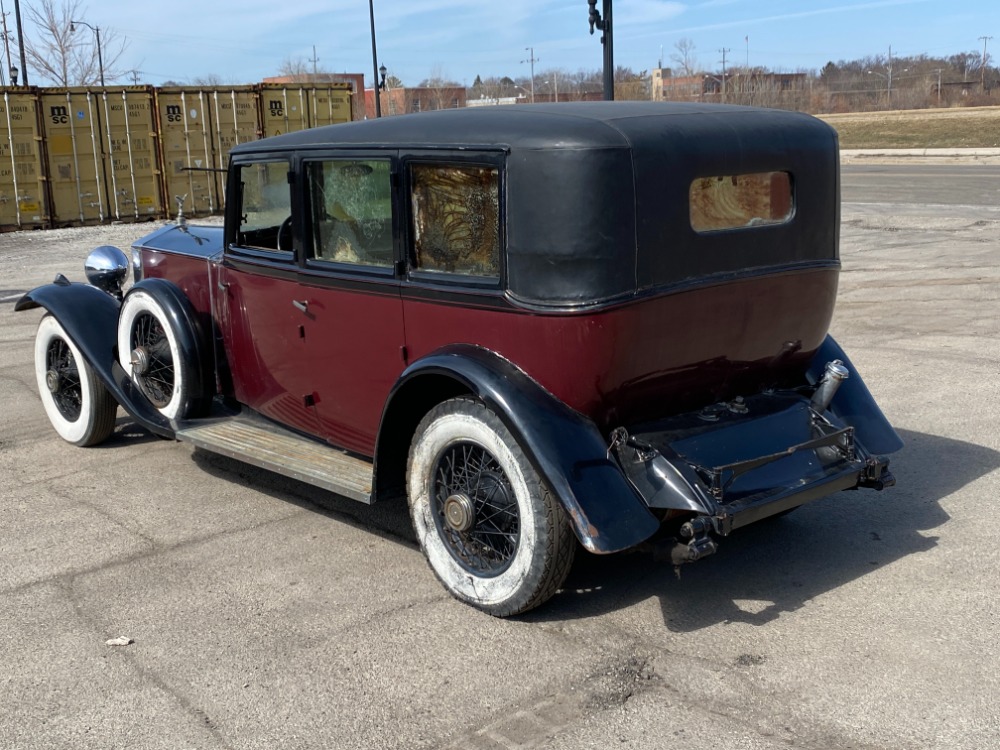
[{"xmin": 434, "ymin": 442, "xmax": 521, "ymax": 576}]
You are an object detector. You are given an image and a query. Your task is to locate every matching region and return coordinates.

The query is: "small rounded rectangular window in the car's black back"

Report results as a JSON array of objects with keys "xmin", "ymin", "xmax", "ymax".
[{"xmin": 689, "ymin": 172, "xmax": 793, "ymax": 232}]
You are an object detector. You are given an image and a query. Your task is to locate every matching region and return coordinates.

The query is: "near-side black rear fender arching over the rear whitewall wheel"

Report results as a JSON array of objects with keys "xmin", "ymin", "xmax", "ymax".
[{"xmin": 376, "ymin": 345, "xmax": 660, "ymax": 554}]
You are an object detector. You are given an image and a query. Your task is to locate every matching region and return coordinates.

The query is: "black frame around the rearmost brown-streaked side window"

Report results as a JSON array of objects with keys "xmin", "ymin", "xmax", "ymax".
[{"xmin": 399, "ymin": 149, "xmax": 507, "ymax": 291}]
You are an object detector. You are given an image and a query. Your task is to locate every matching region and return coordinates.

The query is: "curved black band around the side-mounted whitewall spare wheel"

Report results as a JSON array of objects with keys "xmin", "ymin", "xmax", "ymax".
[{"xmin": 122, "ymin": 279, "xmax": 214, "ymax": 418}]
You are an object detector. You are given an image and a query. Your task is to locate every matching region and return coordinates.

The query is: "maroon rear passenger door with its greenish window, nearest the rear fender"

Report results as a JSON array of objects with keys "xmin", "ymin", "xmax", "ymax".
[{"xmin": 299, "ymin": 149, "xmax": 406, "ymax": 456}]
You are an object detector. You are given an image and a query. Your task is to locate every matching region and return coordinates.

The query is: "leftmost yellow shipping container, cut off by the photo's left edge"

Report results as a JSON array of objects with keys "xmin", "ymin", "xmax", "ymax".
[{"xmin": 0, "ymin": 88, "xmax": 49, "ymax": 230}]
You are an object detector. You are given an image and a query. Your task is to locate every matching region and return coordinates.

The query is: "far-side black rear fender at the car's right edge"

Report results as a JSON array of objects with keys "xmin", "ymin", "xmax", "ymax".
[{"xmin": 806, "ymin": 336, "xmax": 903, "ymax": 456}]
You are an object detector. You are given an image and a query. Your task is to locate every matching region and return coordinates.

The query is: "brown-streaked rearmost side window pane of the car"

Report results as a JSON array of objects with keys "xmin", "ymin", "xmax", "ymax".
[{"xmin": 410, "ymin": 162, "xmax": 500, "ymax": 277}]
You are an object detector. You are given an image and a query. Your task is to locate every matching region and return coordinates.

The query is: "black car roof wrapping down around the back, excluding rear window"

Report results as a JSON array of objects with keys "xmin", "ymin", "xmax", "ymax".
[{"xmin": 233, "ymin": 102, "xmax": 839, "ymax": 306}]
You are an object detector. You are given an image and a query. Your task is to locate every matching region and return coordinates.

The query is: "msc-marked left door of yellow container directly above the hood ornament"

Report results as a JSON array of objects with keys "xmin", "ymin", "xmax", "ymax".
[{"xmin": 156, "ymin": 87, "xmax": 219, "ymax": 216}]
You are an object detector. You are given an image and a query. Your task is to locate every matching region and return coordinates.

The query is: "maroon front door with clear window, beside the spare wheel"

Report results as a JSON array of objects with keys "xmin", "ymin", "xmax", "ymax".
[{"xmin": 218, "ymin": 154, "xmax": 322, "ymax": 435}]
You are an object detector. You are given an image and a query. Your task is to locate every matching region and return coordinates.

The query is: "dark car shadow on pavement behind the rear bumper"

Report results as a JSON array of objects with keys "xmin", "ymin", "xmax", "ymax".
[{"xmin": 525, "ymin": 431, "xmax": 1000, "ymax": 632}]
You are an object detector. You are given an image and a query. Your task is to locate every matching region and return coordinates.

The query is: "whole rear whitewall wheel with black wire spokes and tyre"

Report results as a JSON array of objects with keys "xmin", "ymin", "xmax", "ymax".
[{"xmin": 407, "ymin": 398, "xmax": 576, "ymax": 617}]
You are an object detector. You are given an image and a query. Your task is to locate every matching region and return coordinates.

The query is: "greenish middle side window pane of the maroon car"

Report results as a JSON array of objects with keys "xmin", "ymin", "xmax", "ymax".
[{"xmin": 306, "ymin": 159, "xmax": 393, "ymax": 267}]
